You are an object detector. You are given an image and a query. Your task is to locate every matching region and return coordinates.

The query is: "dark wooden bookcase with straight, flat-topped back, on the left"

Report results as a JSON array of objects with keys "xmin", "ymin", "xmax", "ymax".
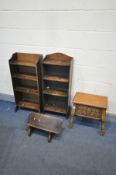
[{"xmin": 9, "ymin": 53, "xmax": 42, "ymax": 111}]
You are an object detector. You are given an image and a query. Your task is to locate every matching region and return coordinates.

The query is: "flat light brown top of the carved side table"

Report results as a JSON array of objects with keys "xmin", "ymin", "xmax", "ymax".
[{"xmin": 73, "ymin": 92, "xmax": 108, "ymax": 109}]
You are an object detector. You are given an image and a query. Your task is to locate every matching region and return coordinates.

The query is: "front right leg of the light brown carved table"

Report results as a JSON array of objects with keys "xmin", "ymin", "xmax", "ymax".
[{"xmin": 100, "ymin": 110, "xmax": 106, "ymax": 136}]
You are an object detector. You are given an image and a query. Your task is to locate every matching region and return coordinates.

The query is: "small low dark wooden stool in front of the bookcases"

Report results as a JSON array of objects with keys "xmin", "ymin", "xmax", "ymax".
[{"xmin": 28, "ymin": 112, "xmax": 63, "ymax": 142}]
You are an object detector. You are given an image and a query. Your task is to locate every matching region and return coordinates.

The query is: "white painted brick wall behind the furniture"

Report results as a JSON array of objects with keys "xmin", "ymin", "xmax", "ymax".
[{"xmin": 0, "ymin": 0, "xmax": 116, "ymax": 114}]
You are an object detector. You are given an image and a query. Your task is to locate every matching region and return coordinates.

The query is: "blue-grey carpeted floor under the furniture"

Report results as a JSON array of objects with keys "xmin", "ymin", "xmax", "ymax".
[{"xmin": 0, "ymin": 101, "xmax": 116, "ymax": 175}]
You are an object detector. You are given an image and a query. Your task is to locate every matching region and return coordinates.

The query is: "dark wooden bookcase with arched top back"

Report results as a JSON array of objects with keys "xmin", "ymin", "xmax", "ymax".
[{"xmin": 42, "ymin": 53, "xmax": 73, "ymax": 116}]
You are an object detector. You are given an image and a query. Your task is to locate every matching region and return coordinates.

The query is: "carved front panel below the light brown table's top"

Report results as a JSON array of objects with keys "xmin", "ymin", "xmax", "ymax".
[{"xmin": 76, "ymin": 105, "xmax": 101, "ymax": 119}]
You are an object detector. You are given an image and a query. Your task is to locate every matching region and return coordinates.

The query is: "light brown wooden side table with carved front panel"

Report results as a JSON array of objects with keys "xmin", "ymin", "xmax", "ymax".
[{"xmin": 69, "ymin": 92, "xmax": 108, "ymax": 136}]
